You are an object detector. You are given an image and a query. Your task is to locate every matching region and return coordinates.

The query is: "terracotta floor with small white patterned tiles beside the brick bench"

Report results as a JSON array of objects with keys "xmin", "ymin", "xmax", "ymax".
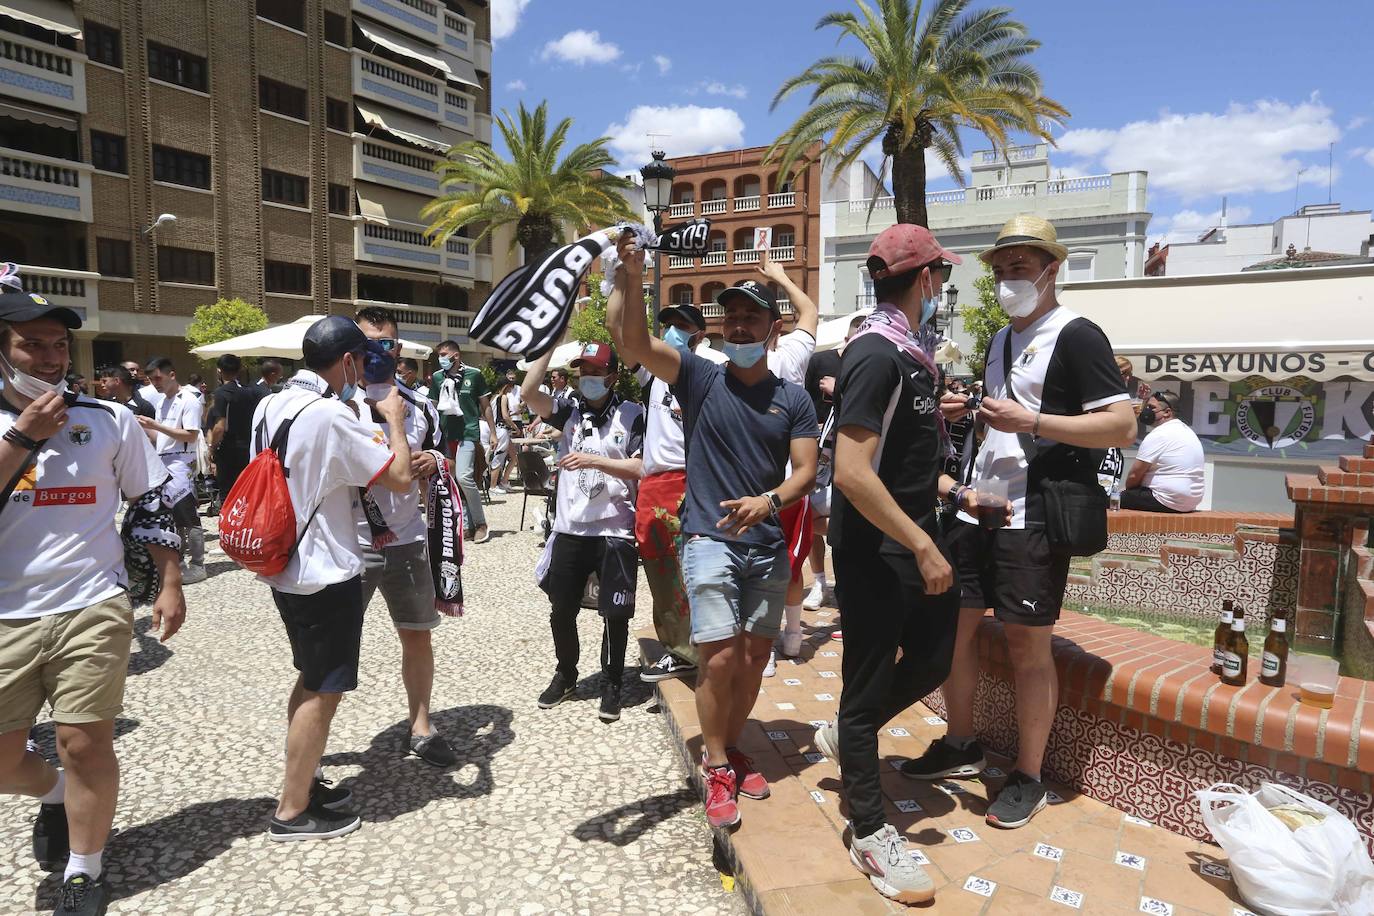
[{"xmin": 640, "ymin": 608, "xmax": 1264, "ymax": 916}]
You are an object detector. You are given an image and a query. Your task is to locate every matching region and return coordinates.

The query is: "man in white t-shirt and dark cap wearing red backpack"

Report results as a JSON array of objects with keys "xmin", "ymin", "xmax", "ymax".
[{"xmin": 245, "ymin": 314, "xmax": 412, "ymax": 840}]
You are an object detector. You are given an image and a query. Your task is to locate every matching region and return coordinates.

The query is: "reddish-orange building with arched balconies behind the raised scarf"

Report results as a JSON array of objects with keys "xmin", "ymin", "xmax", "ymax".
[{"xmin": 664, "ymin": 147, "xmax": 826, "ymax": 339}]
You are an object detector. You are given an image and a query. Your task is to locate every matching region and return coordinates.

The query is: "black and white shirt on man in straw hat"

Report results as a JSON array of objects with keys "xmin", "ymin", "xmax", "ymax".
[{"xmin": 959, "ymin": 305, "xmax": 1128, "ymax": 529}]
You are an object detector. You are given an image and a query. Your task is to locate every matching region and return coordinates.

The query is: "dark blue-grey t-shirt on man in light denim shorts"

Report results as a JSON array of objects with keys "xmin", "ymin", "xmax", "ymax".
[{"xmin": 673, "ymin": 353, "xmax": 820, "ymax": 547}]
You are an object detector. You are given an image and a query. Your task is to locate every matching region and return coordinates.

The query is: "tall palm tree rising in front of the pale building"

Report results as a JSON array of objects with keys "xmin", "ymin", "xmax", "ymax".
[{"xmin": 767, "ymin": 0, "xmax": 1069, "ymax": 225}]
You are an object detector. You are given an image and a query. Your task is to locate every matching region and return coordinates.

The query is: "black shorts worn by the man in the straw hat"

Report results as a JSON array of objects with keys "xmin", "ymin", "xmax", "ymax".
[{"xmin": 947, "ymin": 519, "xmax": 1069, "ymax": 626}]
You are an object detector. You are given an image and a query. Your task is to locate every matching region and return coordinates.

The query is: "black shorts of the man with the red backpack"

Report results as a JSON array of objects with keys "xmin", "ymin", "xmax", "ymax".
[{"xmin": 272, "ymin": 575, "xmax": 363, "ymax": 694}]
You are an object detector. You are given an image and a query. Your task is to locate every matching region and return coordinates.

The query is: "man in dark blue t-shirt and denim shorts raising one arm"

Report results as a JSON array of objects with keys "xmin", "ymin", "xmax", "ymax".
[{"xmin": 606, "ymin": 234, "xmax": 818, "ymax": 827}]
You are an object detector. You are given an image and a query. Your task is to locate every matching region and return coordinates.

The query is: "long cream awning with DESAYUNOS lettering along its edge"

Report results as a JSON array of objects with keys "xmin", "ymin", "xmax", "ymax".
[{"xmin": 1059, "ymin": 265, "xmax": 1374, "ymax": 380}]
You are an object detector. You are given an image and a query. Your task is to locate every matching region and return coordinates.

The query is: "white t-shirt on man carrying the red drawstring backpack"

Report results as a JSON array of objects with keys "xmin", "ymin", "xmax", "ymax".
[{"xmin": 249, "ymin": 369, "xmax": 396, "ymax": 595}]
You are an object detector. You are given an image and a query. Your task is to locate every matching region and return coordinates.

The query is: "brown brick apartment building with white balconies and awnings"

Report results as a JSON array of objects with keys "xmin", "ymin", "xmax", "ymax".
[{"xmin": 0, "ymin": 0, "xmax": 492, "ymax": 374}]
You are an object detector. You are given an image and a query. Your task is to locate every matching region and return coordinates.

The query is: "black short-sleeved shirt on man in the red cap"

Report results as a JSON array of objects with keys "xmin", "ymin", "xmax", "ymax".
[{"xmin": 830, "ymin": 334, "xmax": 943, "ymax": 555}]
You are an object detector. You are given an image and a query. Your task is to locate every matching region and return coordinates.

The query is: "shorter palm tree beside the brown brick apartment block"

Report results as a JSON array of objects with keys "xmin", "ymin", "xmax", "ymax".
[{"xmin": 420, "ymin": 102, "xmax": 635, "ymax": 258}]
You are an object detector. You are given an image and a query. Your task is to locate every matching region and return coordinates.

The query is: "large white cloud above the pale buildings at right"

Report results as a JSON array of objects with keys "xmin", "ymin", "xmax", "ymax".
[{"xmin": 1059, "ymin": 93, "xmax": 1341, "ymax": 202}]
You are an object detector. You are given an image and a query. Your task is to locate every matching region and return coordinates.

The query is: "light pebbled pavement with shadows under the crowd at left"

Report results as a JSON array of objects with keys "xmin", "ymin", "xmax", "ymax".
[{"xmin": 0, "ymin": 497, "xmax": 743, "ymax": 916}]
